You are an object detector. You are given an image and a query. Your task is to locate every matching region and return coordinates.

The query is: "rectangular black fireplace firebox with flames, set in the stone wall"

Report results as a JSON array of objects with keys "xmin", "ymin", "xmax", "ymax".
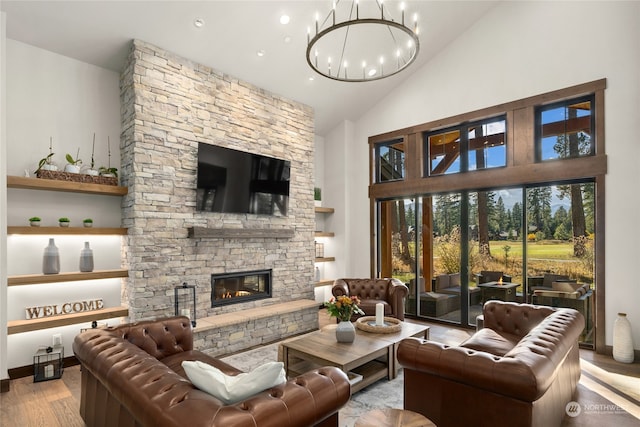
[{"xmin": 211, "ymin": 270, "xmax": 271, "ymax": 307}]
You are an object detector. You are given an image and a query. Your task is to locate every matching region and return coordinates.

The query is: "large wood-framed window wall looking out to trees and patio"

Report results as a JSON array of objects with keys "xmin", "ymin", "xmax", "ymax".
[{"xmin": 369, "ymin": 79, "xmax": 607, "ymax": 352}]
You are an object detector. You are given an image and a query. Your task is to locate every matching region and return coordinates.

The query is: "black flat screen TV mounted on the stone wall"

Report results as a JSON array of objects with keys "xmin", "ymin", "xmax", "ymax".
[{"xmin": 196, "ymin": 142, "xmax": 291, "ymax": 216}]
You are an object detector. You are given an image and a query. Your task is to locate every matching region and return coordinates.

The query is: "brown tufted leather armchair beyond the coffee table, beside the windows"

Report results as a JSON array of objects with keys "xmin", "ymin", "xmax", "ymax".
[{"xmin": 331, "ymin": 279, "xmax": 409, "ymax": 320}]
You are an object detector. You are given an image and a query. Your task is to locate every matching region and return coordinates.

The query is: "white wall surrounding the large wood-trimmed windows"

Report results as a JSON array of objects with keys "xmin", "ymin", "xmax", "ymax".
[{"xmin": 338, "ymin": 2, "xmax": 640, "ymax": 349}]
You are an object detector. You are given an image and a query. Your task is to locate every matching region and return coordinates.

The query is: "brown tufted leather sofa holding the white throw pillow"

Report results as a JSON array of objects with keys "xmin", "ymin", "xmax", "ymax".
[{"xmin": 73, "ymin": 317, "xmax": 350, "ymax": 427}]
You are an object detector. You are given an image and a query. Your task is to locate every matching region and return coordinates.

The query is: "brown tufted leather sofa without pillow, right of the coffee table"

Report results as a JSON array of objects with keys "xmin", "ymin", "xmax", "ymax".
[{"xmin": 398, "ymin": 300, "xmax": 584, "ymax": 427}]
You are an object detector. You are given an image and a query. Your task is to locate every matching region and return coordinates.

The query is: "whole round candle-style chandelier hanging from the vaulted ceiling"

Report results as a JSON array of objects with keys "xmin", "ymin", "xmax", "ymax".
[{"xmin": 307, "ymin": 0, "xmax": 420, "ymax": 82}]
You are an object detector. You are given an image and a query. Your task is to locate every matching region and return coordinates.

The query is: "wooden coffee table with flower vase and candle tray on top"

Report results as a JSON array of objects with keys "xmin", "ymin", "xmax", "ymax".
[{"xmin": 278, "ymin": 322, "xmax": 429, "ymax": 393}]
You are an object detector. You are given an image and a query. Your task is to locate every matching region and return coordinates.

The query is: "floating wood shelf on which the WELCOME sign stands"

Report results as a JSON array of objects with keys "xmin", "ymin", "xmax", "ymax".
[{"xmin": 7, "ymin": 307, "xmax": 129, "ymax": 335}]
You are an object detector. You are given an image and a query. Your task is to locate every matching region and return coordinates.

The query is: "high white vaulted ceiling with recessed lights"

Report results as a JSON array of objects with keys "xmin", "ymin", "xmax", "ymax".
[{"xmin": 0, "ymin": 0, "xmax": 497, "ymax": 135}]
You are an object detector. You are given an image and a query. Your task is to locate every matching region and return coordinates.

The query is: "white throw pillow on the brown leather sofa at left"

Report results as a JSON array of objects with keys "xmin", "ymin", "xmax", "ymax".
[{"xmin": 182, "ymin": 361, "xmax": 287, "ymax": 405}]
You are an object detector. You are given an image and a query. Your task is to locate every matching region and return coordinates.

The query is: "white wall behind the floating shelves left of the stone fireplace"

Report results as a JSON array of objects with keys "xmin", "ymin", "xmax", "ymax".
[{"xmin": 0, "ymin": 39, "xmax": 121, "ymax": 368}]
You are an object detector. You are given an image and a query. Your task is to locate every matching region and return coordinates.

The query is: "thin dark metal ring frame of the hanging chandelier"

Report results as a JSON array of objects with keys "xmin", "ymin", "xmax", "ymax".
[{"xmin": 306, "ymin": 1, "xmax": 420, "ymax": 82}]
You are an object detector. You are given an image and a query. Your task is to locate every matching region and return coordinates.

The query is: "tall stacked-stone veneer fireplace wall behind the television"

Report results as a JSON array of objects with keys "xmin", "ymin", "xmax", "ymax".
[{"xmin": 121, "ymin": 40, "xmax": 317, "ymax": 350}]
